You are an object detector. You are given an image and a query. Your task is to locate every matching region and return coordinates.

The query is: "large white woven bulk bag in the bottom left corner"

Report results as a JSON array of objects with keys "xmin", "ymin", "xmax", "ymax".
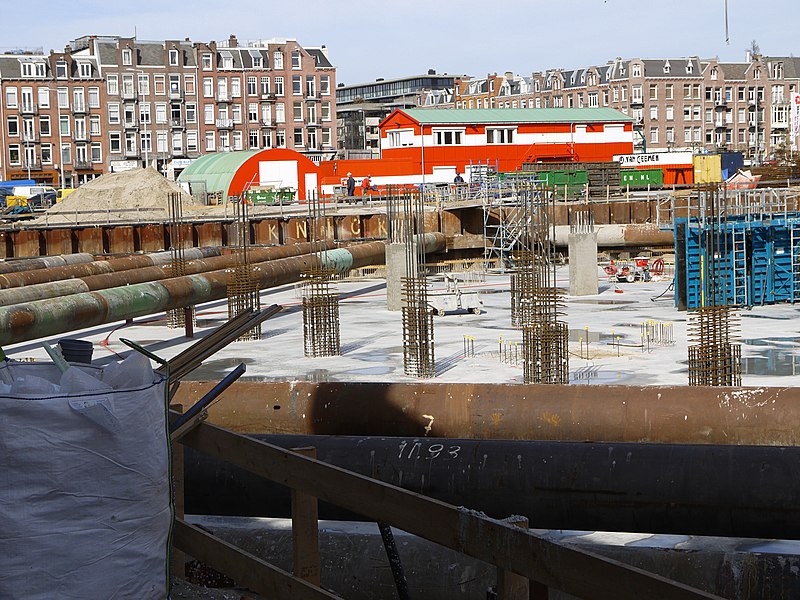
[{"xmin": 0, "ymin": 362, "xmax": 172, "ymax": 600}]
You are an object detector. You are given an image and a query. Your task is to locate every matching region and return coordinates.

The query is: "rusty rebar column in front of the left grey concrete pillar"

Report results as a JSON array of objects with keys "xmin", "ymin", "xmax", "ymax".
[{"xmin": 387, "ymin": 185, "xmax": 436, "ymax": 378}]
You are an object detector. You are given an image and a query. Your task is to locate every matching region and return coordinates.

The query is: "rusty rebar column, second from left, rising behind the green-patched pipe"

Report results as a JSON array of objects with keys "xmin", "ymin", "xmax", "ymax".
[{"xmin": 228, "ymin": 195, "xmax": 261, "ymax": 341}]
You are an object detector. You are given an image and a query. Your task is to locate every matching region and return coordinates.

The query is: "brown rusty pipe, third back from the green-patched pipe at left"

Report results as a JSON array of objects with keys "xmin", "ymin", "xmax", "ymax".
[{"xmin": 0, "ymin": 247, "xmax": 219, "ymax": 289}]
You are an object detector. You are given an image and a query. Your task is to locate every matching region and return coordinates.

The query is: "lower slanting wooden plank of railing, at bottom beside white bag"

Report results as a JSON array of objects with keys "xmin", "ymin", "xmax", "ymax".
[{"xmin": 173, "ymin": 519, "xmax": 341, "ymax": 600}]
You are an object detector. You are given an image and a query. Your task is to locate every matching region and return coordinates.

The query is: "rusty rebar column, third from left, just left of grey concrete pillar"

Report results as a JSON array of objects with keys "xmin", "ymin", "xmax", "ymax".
[{"xmin": 302, "ymin": 193, "xmax": 342, "ymax": 358}]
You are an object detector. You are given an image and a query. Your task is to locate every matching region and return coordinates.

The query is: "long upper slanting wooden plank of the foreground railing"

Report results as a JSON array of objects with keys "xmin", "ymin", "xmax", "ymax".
[{"xmin": 181, "ymin": 423, "xmax": 721, "ymax": 600}]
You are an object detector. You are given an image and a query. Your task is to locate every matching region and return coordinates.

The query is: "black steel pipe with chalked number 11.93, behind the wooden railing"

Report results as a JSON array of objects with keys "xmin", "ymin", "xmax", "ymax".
[{"xmin": 184, "ymin": 435, "xmax": 800, "ymax": 539}]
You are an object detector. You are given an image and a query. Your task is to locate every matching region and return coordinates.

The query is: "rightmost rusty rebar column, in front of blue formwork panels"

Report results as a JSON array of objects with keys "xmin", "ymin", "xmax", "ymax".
[{"xmin": 688, "ymin": 185, "xmax": 742, "ymax": 386}]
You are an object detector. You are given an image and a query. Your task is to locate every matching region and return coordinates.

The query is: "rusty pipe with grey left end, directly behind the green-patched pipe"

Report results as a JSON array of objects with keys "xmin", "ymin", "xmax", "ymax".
[{"xmin": 0, "ymin": 242, "xmax": 333, "ymax": 306}]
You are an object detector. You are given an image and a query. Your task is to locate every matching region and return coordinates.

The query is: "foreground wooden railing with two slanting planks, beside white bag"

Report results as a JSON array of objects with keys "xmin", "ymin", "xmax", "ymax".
[{"xmin": 174, "ymin": 423, "xmax": 718, "ymax": 600}]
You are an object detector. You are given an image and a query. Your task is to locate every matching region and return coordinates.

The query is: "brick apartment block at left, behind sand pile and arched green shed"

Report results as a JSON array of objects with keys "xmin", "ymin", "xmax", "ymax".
[{"xmin": 0, "ymin": 36, "xmax": 336, "ymax": 187}]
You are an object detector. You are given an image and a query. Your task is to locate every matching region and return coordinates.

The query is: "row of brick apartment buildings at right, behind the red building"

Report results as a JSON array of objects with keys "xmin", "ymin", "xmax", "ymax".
[{"xmin": 425, "ymin": 55, "xmax": 800, "ymax": 163}]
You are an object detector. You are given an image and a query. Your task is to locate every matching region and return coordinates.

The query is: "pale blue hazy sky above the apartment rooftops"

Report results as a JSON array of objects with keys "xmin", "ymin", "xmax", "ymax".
[{"xmin": 6, "ymin": 0, "xmax": 800, "ymax": 85}]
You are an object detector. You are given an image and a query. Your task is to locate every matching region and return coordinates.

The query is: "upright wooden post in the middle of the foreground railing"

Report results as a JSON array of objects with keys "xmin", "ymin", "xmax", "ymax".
[{"xmin": 292, "ymin": 448, "xmax": 320, "ymax": 586}]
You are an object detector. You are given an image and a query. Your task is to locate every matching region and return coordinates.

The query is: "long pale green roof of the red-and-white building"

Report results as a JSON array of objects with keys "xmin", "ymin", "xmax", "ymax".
[{"xmin": 402, "ymin": 108, "xmax": 633, "ymax": 125}]
